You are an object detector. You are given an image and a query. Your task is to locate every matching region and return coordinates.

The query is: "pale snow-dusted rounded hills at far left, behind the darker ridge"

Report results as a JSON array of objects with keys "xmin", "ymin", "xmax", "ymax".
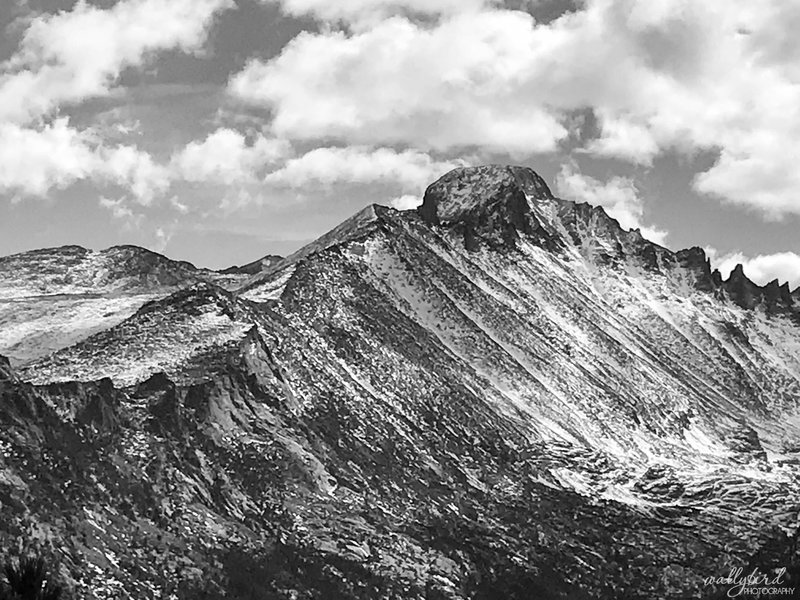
[{"xmin": 0, "ymin": 246, "xmax": 278, "ymax": 364}]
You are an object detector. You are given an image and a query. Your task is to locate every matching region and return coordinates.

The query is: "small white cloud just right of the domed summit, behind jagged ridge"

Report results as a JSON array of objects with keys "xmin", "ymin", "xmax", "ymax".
[{"xmin": 556, "ymin": 165, "xmax": 667, "ymax": 244}]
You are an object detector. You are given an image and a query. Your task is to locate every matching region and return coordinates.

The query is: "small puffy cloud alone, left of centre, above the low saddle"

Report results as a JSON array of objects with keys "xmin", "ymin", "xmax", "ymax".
[{"xmin": 172, "ymin": 128, "xmax": 291, "ymax": 185}]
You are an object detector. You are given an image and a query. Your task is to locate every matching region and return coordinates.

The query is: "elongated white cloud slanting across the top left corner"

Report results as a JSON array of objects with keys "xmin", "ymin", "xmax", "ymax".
[{"xmin": 0, "ymin": 0, "xmax": 234, "ymax": 123}]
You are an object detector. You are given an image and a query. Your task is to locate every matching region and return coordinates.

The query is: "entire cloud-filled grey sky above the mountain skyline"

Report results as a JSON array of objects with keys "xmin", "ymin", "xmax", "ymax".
[{"xmin": 0, "ymin": 0, "xmax": 800, "ymax": 287}]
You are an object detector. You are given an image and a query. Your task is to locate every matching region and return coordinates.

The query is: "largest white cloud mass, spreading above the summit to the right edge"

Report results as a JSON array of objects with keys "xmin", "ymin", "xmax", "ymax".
[{"xmin": 229, "ymin": 0, "xmax": 800, "ymax": 218}]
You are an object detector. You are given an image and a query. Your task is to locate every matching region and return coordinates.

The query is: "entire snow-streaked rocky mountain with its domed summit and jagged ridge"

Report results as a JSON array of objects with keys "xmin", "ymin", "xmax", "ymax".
[{"xmin": 0, "ymin": 166, "xmax": 800, "ymax": 600}]
